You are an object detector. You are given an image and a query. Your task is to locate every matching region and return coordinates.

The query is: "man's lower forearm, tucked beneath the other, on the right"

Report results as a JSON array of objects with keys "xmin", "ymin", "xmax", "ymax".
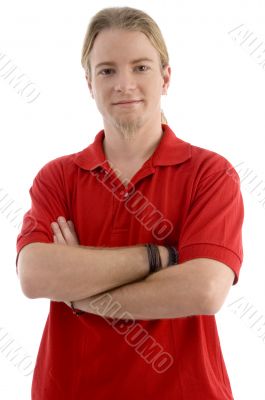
[{"xmin": 70, "ymin": 263, "xmax": 208, "ymax": 320}]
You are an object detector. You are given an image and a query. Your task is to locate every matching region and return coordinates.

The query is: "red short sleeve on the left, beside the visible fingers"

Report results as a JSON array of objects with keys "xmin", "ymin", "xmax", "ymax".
[{"xmin": 16, "ymin": 161, "xmax": 69, "ymax": 266}]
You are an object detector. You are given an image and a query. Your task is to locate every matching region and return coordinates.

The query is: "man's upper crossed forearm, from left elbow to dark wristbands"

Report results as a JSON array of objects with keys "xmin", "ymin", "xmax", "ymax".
[{"xmin": 18, "ymin": 243, "xmax": 153, "ymax": 301}]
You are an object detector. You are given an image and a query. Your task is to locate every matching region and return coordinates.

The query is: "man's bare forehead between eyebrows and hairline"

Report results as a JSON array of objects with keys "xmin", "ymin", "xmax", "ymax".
[{"xmin": 90, "ymin": 29, "xmax": 159, "ymax": 64}]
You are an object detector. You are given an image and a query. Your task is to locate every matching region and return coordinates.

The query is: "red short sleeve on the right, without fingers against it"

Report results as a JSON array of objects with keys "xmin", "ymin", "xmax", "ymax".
[{"xmin": 179, "ymin": 163, "xmax": 244, "ymax": 285}]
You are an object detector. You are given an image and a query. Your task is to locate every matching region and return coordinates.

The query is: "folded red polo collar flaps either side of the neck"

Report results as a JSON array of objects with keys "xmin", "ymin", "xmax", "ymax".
[{"xmin": 73, "ymin": 124, "xmax": 191, "ymax": 170}]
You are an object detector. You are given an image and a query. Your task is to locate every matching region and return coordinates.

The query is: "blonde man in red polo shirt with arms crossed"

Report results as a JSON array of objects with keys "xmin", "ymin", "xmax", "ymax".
[{"xmin": 17, "ymin": 7, "xmax": 243, "ymax": 400}]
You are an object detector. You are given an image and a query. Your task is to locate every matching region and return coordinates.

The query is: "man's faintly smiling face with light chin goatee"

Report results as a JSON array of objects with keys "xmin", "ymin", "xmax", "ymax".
[{"xmin": 86, "ymin": 29, "xmax": 171, "ymax": 138}]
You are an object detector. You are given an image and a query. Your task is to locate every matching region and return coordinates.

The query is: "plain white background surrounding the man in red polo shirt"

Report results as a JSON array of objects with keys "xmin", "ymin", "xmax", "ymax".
[{"xmin": 0, "ymin": 0, "xmax": 265, "ymax": 400}]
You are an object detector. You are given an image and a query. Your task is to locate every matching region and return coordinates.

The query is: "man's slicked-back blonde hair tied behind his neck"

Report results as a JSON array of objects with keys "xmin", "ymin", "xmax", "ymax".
[{"xmin": 81, "ymin": 7, "xmax": 169, "ymax": 124}]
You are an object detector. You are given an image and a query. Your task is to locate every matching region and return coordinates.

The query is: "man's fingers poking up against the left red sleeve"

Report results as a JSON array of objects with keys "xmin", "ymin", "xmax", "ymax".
[{"xmin": 51, "ymin": 216, "xmax": 79, "ymax": 246}]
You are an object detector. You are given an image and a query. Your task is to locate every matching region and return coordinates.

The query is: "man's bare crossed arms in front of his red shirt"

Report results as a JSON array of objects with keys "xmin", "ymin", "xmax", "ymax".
[{"xmin": 18, "ymin": 217, "xmax": 234, "ymax": 319}]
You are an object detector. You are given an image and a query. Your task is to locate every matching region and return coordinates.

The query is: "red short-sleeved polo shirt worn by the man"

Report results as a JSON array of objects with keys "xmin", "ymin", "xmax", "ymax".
[{"xmin": 17, "ymin": 125, "xmax": 244, "ymax": 400}]
